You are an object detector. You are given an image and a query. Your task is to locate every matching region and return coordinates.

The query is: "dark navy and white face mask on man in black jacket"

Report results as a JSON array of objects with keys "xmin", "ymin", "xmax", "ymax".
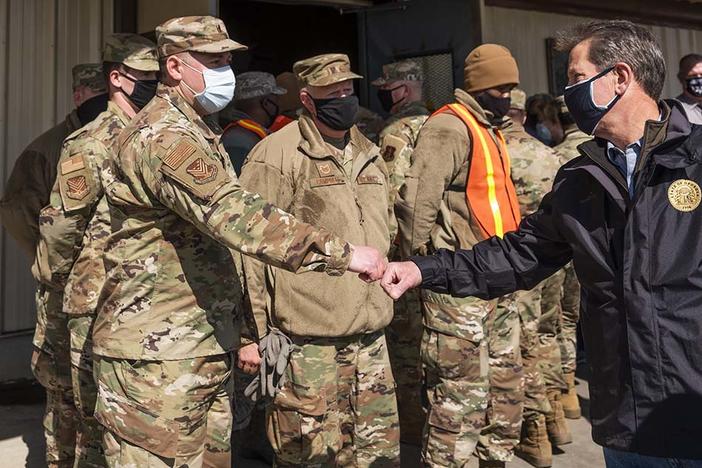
[{"xmin": 563, "ymin": 67, "xmax": 621, "ymax": 135}]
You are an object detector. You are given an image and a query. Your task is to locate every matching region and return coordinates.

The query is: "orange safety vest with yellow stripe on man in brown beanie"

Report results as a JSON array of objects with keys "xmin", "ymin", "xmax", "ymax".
[{"xmin": 435, "ymin": 103, "xmax": 521, "ymax": 237}]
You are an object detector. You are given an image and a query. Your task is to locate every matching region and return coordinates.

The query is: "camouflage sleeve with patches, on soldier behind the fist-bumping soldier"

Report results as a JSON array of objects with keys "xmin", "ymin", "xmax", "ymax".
[{"xmin": 33, "ymin": 139, "xmax": 106, "ymax": 290}]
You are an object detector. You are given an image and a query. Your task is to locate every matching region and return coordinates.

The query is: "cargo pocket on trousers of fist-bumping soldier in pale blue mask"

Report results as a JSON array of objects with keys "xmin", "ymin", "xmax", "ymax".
[{"xmin": 95, "ymin": 385, "xmax": 179, "ymax": 458}]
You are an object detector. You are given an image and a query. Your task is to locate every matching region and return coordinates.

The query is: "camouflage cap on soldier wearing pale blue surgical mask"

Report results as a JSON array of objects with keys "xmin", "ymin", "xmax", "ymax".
[{"xmin": 156, "ymin": 16, "xmax": 247, "ymax": 57}]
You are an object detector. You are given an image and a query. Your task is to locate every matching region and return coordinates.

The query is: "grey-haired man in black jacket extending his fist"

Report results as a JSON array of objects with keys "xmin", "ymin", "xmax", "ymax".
[{"xmin": 383, "ymin": 17, "xmax": 702, "ymax": 467}]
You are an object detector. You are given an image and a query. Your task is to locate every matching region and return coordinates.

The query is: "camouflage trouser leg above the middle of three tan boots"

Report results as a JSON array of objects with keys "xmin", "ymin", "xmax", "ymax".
[{"xmin": 537, "ymin": 270, "xmax": 568, "ymax": 392}]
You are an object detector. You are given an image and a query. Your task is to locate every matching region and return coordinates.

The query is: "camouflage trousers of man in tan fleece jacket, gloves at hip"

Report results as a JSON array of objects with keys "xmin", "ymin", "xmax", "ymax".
[{"xmin": 266, "ymin": 331, "xmax": 400, "ymax": 467}]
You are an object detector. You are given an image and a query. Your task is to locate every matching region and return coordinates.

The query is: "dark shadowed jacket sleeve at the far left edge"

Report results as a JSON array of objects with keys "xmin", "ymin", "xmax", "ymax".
[{"xmin": 0, "ymin": 150, "xmax": 51, "ymax": 258}]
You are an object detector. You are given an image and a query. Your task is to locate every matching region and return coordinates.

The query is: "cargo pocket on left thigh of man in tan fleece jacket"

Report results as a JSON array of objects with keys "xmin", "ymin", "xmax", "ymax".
[{"xmin": 267, "ymin": 386, "xmax": 341, "ymax": 465}]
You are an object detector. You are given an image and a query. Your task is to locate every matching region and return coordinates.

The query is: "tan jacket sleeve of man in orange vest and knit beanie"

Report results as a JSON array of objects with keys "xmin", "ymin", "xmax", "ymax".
[{"xmin": 395, "ymin": 115, "xmax": 470, "ymax": 258}]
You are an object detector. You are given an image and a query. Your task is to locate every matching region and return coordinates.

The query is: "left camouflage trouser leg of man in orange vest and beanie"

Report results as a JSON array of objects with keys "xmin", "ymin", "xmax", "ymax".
[{"xmin": 421, "ymin": 290, "xmax": 495, "ymax": 467}]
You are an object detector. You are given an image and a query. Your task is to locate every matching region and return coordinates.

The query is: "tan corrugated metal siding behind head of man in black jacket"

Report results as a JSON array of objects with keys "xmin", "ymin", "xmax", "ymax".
[{"xmin": 483, "ymin": 6, "xmax": 702, "ymax": 97}]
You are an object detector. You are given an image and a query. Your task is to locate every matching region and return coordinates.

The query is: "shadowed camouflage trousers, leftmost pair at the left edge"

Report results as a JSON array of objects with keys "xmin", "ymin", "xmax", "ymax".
[{"xmin": 31, "ymin": 287, "xmax": 79, "ymax": 468}]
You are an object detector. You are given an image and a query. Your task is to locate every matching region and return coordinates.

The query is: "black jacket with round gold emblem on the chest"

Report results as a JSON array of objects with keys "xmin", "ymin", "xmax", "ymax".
[{"xmin": 412, "ymin": 103, "xmax": 702, "ymax": 459}]
